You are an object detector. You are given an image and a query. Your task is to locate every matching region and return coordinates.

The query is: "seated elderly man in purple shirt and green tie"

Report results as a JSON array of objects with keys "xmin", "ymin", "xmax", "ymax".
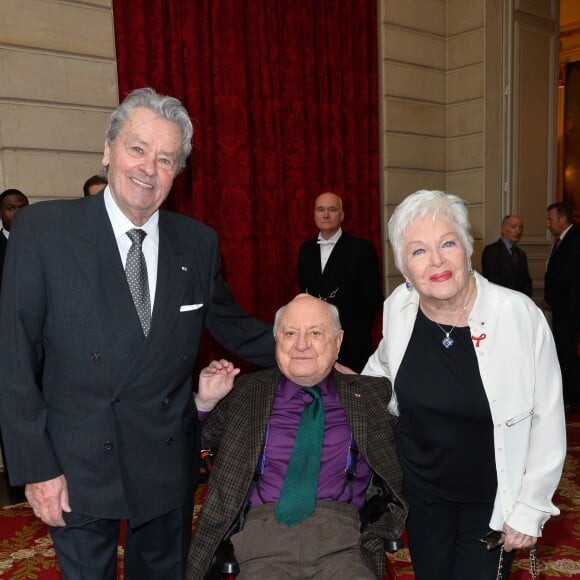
[{"xmin": 187, "ymin": 294, "xmax": 407, "ymax": 580}]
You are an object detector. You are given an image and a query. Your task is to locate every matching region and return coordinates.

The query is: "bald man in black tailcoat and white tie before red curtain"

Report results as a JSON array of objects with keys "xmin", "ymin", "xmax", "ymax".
[{"xmin": 298, "ymin": 192, "xmax": 383, "ymax": 372}]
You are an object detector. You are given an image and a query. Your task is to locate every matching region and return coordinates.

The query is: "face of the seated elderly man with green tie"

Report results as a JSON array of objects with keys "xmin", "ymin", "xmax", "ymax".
[{"xmin": 276, "ymin": 294, "xmax": 343, "ymax": 387}]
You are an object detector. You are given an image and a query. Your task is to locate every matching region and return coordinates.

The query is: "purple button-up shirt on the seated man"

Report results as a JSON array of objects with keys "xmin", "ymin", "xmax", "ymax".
[{"xmin": 250, "ymin": 376, "xmax": 372, "ymax": 507}]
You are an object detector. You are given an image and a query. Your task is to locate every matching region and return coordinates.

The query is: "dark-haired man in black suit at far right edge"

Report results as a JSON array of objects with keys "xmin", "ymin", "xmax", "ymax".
[{"xmin": 544, "ymin": 202, "xmax": 580, "ymax": 407}]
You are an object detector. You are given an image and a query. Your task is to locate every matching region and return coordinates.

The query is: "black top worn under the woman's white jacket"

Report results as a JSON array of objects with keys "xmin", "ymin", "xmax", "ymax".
[{"xmin": 395, "ymin": 309, "xmax": 497, "ymax": 502}]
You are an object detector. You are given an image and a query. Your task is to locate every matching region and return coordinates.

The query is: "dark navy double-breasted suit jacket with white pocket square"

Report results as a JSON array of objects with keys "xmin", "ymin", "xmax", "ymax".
[{"xmin": 0, "ymin": 193, "xmax": 274, "ymax": 525}]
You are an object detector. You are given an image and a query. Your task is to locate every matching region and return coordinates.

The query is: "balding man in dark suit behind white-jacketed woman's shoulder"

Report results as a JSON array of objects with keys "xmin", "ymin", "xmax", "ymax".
[{"xmin": 481, "ymin": 215, "xmax": 532, "ymax": 296}]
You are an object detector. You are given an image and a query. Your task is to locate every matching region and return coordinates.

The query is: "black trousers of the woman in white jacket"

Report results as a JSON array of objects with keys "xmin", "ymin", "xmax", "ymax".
[{"xmin": 405, "ymin": 493, "xmax": 514, "ymax": 580}]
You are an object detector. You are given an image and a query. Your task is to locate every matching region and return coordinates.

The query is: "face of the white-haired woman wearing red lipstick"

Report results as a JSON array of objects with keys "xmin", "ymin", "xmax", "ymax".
[{"xmin": 403, "ymin": 214, "xmax": 470, "ymax": 303}]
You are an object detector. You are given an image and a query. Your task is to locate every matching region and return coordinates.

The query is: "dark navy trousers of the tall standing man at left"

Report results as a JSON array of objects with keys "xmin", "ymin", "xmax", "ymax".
[{"xmin": 50, "ymin": 501, "xmax": 193, "ymax": 580}]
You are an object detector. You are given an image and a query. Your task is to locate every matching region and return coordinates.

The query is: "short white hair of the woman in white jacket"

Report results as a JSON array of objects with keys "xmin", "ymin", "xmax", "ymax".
[{"xmin": 389, "ymin": 189, "xmax": 473, "ymax": 274}]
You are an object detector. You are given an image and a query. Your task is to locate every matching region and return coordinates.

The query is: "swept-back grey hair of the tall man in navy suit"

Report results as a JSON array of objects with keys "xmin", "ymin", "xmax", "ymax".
[{"xmin": 105, "ymin": 87, "xmax": 193, "ymax": 173}]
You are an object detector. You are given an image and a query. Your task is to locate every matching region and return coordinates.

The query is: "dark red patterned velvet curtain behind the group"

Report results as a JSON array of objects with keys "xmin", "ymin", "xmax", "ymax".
[{"xmin": 113, "ymin": 0, "xmax": 381, "ymax": 368}]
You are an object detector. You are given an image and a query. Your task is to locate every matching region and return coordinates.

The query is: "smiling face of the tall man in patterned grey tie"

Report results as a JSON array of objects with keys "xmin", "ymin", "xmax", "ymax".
[{"xmin": 103, "ymin": 108, "xmax": 181, "ymax": 226}]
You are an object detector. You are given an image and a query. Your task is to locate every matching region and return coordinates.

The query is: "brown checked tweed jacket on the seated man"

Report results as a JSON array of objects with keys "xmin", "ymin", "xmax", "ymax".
[{"xmin": 187, "ymin": 369, "xmax": 407, "ymax": 580}]
